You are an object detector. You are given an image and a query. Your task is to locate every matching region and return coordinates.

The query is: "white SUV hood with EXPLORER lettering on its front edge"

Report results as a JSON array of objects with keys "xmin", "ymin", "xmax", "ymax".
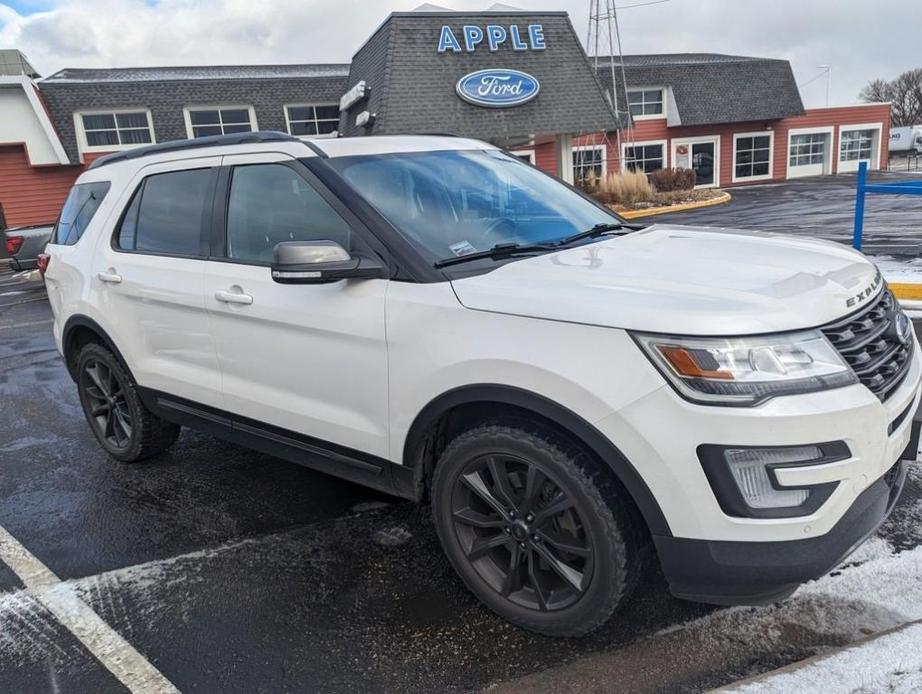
[{"xmin": 452, "ymin": 224, "xmax": 880, "ymax": 335}]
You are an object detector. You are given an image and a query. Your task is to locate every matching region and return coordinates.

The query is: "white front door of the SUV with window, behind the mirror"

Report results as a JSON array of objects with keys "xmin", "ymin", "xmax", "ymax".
[{"xmin": 204, "ymin": 153, "xmax": 388, "ymax": 457}]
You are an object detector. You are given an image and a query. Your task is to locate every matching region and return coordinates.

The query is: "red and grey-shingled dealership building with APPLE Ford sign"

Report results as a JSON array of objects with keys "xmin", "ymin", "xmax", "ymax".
[{"xmin": 0, "ymin": 5, "xmax": 890, "ymax": 226}]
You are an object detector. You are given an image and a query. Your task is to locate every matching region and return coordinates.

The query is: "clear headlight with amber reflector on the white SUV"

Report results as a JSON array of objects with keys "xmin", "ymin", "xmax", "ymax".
[{"xmin": 634, "ymin": 330, "xmax": 858, "ymax": 407}]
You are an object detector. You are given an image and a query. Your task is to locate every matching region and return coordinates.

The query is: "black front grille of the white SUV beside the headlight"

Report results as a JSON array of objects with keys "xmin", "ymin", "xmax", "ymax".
[{"xmin": 821, "ymin": 287, "xmax": 913, "ymax": 400}]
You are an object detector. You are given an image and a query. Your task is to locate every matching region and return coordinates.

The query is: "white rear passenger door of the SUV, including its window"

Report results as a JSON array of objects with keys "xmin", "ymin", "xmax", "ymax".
[{"xmin": 91, "ymin": 157, "xmax": 222, "ymax": 407}]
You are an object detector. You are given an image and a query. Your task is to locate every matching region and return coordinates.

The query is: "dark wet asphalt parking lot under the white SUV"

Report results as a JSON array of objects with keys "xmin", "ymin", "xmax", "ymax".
[{"xmin": 0, "ymin": 256, "xmax": 922, "ymax": 692}]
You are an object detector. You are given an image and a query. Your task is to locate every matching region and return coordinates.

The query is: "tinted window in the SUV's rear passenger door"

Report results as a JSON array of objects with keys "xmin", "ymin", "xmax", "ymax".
[{"xmin": 115, "ymin": 169, "xmax": 214, "ymax": 256}]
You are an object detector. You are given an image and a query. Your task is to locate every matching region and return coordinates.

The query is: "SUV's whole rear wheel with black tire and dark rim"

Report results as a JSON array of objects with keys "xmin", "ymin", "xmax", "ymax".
[{"xmin": 77, "ymin": 343, "xmax": 180, "ymax": 463}]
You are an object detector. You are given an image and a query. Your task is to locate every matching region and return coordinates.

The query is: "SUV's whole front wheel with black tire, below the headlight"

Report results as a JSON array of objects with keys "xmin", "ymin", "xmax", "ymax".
[{"xmin": 432, "ymin": 425, "xmax": 640, "ymax": 636}]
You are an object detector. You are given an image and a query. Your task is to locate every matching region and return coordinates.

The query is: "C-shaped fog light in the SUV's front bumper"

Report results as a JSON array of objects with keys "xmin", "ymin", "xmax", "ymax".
[{"xmin": 724, "ymin": 446, "xmax": 823, "ymax": 509}]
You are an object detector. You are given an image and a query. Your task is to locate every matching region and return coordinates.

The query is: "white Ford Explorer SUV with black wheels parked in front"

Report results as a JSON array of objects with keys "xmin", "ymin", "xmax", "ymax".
[{"xmin": 43, "ymin": 133, "xmax": 922, "ymax": 635}]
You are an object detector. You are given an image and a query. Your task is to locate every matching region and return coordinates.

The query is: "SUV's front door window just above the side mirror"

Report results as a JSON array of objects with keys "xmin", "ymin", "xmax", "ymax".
[{"xmin": 227, "ymin": 164, "xmax": 350, "ymax": 263}]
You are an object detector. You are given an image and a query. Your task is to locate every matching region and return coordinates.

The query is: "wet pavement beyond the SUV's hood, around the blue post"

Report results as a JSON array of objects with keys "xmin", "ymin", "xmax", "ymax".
[{"xmin": 652, "ymin": 172, "xmax": 922, "ymax": 255}]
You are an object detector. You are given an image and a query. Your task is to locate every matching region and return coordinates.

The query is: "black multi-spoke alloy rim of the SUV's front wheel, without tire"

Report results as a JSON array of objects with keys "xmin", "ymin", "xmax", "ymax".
[{"xmin": 452, "ymin": 453, "xmax": 593, "ymax": 611}]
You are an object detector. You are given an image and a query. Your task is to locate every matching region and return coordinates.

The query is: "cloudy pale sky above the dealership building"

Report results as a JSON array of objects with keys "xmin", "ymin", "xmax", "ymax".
[{"xmin": 0, "ymin": 0, "xmax": 922, "ymax": 107}]
